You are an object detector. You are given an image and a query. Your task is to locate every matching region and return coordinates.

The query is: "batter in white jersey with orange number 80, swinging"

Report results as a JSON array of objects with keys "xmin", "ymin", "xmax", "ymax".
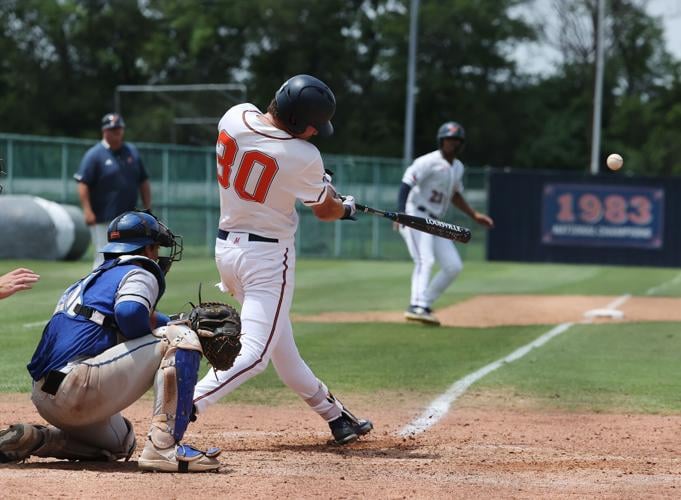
[{"xmin": 194, "ymin": 75, "xmax": 373, "ymax": 444}]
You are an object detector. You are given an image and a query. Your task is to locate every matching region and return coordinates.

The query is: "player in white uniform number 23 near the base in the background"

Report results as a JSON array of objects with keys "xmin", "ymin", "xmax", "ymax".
[{"xmin": 397, "ymin": 122, "xmax": 494, "ymax": 325}]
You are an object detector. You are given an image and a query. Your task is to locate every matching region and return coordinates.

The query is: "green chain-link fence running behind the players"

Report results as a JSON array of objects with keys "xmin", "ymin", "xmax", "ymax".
[{"xmin": 0, "ymin": 134, "xmax": 486, "ymax": 259}]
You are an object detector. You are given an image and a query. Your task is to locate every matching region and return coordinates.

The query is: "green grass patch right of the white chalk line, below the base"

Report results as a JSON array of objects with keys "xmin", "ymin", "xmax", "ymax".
[{"xmin": 477, "ymin": 323, "xmax": 681, "ymax": 412}]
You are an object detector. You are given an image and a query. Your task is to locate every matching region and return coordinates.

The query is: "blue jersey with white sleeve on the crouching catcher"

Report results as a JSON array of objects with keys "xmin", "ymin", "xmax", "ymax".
[{"xmin": 27, "ymin": 256, "xmax": 165, "ymax": 380}]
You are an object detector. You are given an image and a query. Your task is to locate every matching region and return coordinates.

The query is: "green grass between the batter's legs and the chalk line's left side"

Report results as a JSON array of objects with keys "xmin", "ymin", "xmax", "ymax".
[{"xmin": 231, "ymin": 323, "xmax": 545, "ymax": 400}]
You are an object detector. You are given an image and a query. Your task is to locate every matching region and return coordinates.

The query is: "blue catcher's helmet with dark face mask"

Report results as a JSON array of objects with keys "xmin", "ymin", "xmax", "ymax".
[{"xmin": 100, "ymin": 211, "xmax": 182, "ymax": 273}]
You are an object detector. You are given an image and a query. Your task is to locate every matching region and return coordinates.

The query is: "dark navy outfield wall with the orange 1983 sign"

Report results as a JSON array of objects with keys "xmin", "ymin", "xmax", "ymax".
[{"xmin": 486, "ymin": 169, "xmax": 681, "ymax": 267}]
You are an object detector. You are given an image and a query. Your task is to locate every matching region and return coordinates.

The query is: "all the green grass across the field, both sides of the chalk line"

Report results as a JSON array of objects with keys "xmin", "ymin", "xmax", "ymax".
[{"xmin": 0, "ymin": 257, "xmax": 681, "ymax": 413}]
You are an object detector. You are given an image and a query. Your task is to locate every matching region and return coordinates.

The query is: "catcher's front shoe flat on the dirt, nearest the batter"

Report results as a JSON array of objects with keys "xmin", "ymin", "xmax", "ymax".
[{"xmin": 137, "ymin": 440, "xmax": 222, "ymax": 472}]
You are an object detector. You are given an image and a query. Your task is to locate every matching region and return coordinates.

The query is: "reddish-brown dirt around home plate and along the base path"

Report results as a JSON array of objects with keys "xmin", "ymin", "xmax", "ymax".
[{"xmin": 0, "ymin": 296, "xmax": 681, "ymax": 499}]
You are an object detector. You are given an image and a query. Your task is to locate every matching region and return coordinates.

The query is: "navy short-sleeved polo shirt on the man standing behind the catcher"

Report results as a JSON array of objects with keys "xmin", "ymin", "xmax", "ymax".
[{"xmin": 73, "ymin": 142, "xmax": 149, "ymax": 223}]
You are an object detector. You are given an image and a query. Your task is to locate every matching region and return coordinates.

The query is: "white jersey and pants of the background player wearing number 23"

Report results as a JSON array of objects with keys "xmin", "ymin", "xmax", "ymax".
[{"xmin": 400, "ymin": 149, "xmax": 464, "ymax": 308}]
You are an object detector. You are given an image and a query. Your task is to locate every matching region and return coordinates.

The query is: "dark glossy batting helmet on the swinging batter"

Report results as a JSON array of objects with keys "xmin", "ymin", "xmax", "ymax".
[{"xmin": 274, "ymin": 75, "xmax": 336, "ymax": 137}]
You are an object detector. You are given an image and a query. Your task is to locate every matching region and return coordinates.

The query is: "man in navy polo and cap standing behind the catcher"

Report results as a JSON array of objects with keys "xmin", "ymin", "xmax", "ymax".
[{"xmin": 73, "ymin": 113, "xmax": 151, "ymax": 269}]
